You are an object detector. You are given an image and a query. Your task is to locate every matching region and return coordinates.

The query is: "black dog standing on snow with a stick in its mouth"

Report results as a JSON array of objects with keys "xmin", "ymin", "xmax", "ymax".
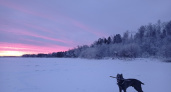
[{"xmin": 110, "ymin": 74, "xmax": 144, "ymax": 92}]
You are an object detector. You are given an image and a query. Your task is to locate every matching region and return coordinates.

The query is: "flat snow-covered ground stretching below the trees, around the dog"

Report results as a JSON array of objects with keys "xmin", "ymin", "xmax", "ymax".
[{"xmin": 0, "ymin": 58, "xmax": 171, "ymax": 92}]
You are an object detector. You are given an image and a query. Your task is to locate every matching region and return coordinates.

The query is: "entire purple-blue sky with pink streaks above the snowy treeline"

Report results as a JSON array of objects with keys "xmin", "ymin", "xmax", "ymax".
[{"xmin": 0, "ymin": 0, "xmax": 171, "ymax": 56}]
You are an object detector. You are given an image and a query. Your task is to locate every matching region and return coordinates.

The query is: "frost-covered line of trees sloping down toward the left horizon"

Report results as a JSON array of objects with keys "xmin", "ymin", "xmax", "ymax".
[{"xmin": 23, "ymin": 20, "xmax": 171, "ymax": 59}]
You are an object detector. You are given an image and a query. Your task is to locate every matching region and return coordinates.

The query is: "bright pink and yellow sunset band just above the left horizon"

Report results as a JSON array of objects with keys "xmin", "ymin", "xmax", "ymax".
[{"xmin": 0, "ymin": 43, "xmax": 69, "ymax": 56}]
